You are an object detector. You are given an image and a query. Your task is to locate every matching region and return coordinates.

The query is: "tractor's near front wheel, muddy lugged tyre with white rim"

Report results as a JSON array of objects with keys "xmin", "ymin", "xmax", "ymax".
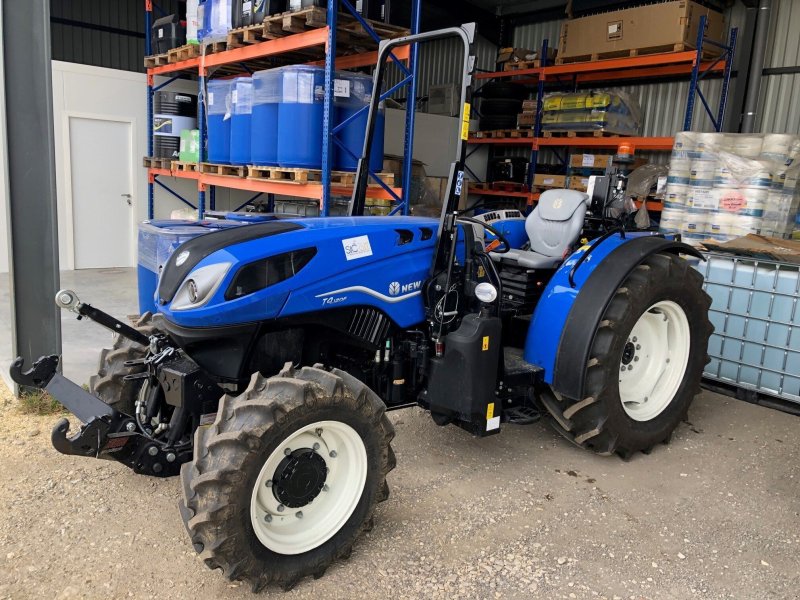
[{"xmin": 180, "ymin": 365, "xmax": 395, "ymax": 591}]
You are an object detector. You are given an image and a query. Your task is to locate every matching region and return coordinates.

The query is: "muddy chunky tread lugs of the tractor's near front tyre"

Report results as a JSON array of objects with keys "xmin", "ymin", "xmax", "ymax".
[{"xmin": 180, "ymin": 365, "xmax": 396, "ymax": 592}]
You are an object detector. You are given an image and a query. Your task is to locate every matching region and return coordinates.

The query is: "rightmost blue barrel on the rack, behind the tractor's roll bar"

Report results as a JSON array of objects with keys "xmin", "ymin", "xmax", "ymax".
[{"xmin": 333, "ymin": 72, "xmax": 386, "ymax": 172}]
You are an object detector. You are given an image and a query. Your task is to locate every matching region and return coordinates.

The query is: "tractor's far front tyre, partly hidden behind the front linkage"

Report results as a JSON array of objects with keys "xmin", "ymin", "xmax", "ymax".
[{"xmin": 89, "ymin": 312, "xmax": 154, "ymax": 415}]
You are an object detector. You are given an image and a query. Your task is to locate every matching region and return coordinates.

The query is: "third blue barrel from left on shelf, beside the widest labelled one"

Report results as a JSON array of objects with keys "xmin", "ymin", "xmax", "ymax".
[{"xmin": 255, "ymin": 69, "xmax": 283, "ymax": 166}]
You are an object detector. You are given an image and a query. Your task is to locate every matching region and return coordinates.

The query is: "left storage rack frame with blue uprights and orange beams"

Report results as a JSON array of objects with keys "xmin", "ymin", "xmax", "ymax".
[{"xmin": 145, "ymin": 0, "xmax": 421, "ymax": 219}]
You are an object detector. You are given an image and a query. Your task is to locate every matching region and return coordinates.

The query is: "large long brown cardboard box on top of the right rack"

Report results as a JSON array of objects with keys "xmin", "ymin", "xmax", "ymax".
[{"xmin": 558, "ymin": 0, "xmax": 725, "ymax": 59}]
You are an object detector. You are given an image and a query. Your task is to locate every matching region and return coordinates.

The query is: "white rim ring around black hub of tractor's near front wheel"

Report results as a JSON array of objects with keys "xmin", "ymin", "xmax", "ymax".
[{"xmin": 250, "ymin": 421, "xmax": 367, "ymax": 554}]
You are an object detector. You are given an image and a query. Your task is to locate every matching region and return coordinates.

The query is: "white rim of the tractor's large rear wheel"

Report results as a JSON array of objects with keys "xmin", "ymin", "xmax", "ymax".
[{"xmin": 619, "ymin": 300, "xmax": 691, "ymax": 421}]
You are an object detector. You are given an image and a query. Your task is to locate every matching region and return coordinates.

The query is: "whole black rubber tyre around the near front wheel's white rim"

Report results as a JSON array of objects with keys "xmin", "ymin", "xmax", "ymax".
[{"xmin": 180, "ymin": 365, "xmax": 395, "ymax": 592}]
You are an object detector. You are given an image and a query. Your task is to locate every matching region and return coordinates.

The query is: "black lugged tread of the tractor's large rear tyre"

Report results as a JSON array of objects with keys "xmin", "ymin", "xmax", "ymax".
[{"xmin": 542, "ymin": 254, "xmax": 713, "ymax": 459}]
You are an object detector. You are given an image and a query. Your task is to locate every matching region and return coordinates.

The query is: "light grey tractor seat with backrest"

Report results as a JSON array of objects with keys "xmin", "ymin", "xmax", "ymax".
[{"xmin": 491, "ymin": 190, "xmax": 589, "ymax": 269}]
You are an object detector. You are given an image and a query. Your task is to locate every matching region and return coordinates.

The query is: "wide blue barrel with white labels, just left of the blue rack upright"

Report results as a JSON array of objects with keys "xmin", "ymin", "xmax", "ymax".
[{"xmin": 278, "ymin": 66, "xmax": 325, "ymax": 169}]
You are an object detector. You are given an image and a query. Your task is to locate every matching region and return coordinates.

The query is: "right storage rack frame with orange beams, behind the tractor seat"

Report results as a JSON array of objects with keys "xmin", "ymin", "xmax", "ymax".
[{"xmin": 468, "ymin": 16, "xmax": 738, "ymax": 208}]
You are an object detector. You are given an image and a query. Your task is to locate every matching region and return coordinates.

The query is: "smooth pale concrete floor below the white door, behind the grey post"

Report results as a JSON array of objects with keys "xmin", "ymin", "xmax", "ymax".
[{"xmin": 0, "ymin": 269, "xmax": 139, "ymax": 387}]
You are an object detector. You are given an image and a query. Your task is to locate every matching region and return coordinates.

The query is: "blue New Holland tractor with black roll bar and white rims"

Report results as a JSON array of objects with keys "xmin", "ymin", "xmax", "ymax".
[{"xmin": 12, "ymin": 26, "xmax": 711, "ymax": 590}]
